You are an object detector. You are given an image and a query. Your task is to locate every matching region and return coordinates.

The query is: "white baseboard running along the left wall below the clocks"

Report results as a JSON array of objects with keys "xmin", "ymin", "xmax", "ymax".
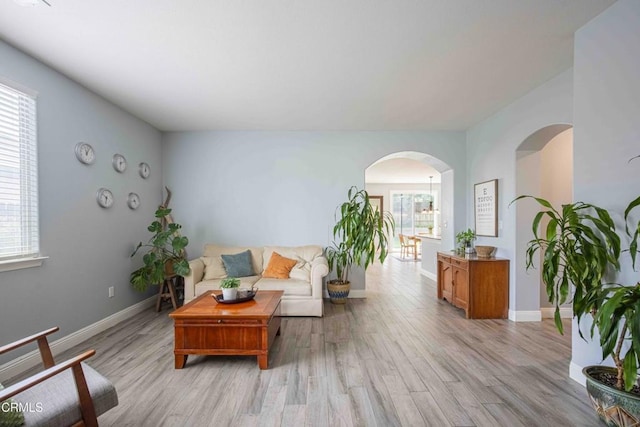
[{"xmin": 0, "ymin": 296, "xmax": 157, "ymax": 381}]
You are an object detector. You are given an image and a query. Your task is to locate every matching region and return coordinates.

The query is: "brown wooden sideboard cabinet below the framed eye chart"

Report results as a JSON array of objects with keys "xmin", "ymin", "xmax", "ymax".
[{"xmin": 438, "ymin": 252, "xmax": 509, "ymax": 319}]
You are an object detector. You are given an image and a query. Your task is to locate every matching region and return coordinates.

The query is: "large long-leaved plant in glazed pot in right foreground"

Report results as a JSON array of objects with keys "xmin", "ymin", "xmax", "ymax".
[{"xmin": 512, "ymin": 192, "xmax": 640, "ymax": 426}]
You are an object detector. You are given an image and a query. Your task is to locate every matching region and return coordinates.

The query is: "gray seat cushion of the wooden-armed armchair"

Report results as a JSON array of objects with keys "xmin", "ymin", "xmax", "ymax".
[{"xmin": 14, "ymin": 363, "xmax": 118, "ymax": 426}]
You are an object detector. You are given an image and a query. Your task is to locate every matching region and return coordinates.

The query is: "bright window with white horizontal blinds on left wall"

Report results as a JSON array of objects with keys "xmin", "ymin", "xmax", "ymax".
[{"xmin": 0, "ymin": 80, "xmax": 40, "ymax": 262}]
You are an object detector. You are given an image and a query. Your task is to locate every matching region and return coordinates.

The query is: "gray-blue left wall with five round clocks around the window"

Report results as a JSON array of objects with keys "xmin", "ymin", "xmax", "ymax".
[{"xmin": 0, "ymin": 41, "xmax": 162, "ymax": 363}]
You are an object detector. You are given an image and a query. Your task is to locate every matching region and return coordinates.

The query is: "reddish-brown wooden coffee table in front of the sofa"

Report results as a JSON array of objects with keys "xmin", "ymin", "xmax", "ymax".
[{"xmin": 169, "ymin": 291, "xmax": 283, "ymax": 369}]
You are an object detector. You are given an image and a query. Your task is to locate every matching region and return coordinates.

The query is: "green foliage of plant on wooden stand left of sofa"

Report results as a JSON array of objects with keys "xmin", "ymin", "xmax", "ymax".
[{"xmin": 129, "ymin": 207, "xmax": 191, "ymax": 292}]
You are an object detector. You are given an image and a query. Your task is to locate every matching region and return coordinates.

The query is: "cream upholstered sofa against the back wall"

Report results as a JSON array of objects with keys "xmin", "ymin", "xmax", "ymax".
[{"xmin": 184, "ymin": 244, "xmax": 329, "ymax": 317}]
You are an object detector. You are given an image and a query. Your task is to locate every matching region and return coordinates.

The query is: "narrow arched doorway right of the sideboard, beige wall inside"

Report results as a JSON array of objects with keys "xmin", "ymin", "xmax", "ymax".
[{"xmin": 512, "ymin": 124, "xmax": 573, "ymax": 321}]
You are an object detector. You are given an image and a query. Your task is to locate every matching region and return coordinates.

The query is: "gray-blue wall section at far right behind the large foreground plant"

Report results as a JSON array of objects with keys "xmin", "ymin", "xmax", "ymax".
[{"xmin": 573, "ymin": 0, "xmax": 640, "ymax": 370}]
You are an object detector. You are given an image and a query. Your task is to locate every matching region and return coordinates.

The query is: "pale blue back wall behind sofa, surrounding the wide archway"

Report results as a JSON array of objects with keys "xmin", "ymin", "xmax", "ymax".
[{"xmin": 163, "ymin": 132, "xmax": 466, "ymax": 289}]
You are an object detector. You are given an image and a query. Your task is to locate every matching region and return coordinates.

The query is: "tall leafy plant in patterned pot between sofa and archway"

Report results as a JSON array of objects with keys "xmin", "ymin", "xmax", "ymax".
[{"xmin": 325, "ymin": 186, "xmax": 395, "ymax": 304}]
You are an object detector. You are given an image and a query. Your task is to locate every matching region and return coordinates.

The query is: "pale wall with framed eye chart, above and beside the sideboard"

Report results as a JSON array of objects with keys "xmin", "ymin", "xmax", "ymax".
[{"xmin": 467, "ymin": 70, "xmax": 573, "ymax": 320}]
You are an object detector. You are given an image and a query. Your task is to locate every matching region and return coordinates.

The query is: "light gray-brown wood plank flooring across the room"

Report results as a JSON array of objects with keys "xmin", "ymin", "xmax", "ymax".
[{"xmin": 52, "ymin": 257, "xmax": 599, "ymax": 427}]
